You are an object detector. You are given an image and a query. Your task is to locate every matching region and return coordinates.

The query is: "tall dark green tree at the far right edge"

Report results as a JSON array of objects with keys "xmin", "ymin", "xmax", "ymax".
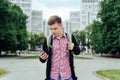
[{"xmin": 99, "ymin": 0, "xmax": 120, "ymax": 53}]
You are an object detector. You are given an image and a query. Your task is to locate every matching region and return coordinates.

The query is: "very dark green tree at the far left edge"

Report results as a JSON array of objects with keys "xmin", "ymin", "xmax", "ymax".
[{"xmin": 0, "ymin": 0, "xmax": 17, "ymax": 54}]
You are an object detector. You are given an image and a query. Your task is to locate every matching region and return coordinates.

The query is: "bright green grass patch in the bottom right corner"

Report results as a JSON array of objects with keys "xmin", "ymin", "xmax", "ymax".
[{"xmin": 97, "ymin": 70, "xmax": 120, "ymax": 80}]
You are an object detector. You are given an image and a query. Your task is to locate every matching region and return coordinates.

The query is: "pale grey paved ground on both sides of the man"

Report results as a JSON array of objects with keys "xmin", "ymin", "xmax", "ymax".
[{"xmin": 0, "ymin": 55, "xmax": 120, "ymax": 80}]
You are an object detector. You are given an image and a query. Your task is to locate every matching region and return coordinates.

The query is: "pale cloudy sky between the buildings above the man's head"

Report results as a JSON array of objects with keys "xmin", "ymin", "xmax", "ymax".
[{"xmin": 32, "ymin": 0, "xmax": 81, "ymax": 20}]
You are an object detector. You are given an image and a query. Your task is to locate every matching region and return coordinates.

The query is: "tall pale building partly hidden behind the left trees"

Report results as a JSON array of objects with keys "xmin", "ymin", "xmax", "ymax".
[{"xmin": 10, "ymin": 0, "xmax": 32, "ymax": 32}]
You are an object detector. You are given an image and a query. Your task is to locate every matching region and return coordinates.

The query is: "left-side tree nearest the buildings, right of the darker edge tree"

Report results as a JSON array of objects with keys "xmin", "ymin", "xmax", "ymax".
[{"xmin": 11, "ymin": 5, "xmax": 28, "ymax": 50}]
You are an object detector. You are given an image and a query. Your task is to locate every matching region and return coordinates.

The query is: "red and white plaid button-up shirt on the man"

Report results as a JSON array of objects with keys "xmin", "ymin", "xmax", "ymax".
[{"xmin": 50, "ymin": 34, "xmax": 71, "ymax": 80}]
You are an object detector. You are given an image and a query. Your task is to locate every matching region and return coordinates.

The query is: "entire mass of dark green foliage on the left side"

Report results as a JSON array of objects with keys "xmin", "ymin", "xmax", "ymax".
[{"xmin": 0, "ymin": 0, "xmax": 27, "ymax": 53}]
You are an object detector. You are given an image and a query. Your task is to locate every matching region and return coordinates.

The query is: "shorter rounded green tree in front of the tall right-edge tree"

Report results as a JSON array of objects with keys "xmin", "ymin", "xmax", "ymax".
[{"xmin": 90, "ymin": 21, "xmax": 104, "ymax": 53}]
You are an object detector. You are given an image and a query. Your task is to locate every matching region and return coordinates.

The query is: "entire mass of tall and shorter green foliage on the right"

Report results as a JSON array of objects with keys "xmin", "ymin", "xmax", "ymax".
[{"xmin": 90, "ymin": 0, "xmax": 120, "ymax": 54}]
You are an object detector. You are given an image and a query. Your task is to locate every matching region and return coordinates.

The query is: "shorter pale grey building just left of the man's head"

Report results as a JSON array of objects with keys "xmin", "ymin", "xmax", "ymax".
[{"xmin": 31, "ymin": 10, "xmax": 44, "ymax": 34}]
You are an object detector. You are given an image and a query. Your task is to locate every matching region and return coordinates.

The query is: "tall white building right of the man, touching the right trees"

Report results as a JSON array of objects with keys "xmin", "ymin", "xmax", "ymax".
[{"xmin": 80, "ymin": 0, "xmax": 100, "ymax": 29}]
